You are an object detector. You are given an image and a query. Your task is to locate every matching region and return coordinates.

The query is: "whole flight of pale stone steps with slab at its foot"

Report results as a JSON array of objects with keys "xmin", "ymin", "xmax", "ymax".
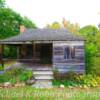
[{"xmin": 32, "ymin": 67, "xmax": 53, "ymax": 88}]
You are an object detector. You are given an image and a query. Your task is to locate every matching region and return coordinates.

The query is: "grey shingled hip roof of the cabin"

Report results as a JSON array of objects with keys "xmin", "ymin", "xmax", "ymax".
[{"xmin": 0, "ymin": 29, "xmax": 83, "ymax": 43}]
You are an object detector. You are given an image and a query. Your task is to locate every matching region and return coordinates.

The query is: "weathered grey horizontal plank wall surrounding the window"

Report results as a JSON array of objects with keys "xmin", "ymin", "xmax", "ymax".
[{"xmin": 53, "ymin": 41, "xmax": 85, "ymax": 73}]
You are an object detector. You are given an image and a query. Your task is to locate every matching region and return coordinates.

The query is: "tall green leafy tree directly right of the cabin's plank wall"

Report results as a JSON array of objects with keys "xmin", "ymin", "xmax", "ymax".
[{"xmin": 79, "ymin": 25, "xmax": 99, "ymax": 74}]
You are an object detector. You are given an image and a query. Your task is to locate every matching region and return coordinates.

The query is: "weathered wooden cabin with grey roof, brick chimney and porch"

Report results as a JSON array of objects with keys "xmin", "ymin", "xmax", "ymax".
[{"xmin": 0, "ymin": 26, "xmax": 85, "ymax": 73}]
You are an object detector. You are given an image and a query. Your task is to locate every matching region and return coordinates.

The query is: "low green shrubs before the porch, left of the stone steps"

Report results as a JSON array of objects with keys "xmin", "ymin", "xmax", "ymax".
[{"xmin": 0, "ymin": 67, "xmax": 33, "ymax": 84}]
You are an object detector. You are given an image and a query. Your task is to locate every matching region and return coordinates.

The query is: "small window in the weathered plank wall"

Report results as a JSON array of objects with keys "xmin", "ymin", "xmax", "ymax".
[{"xmin": 64, "ymin": 46, "xmax": 75, "ymax": 59}]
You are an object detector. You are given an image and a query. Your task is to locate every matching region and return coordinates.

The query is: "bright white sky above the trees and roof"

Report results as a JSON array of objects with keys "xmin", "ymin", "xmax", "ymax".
[{"xmin": 6, "ymin": 0, "xmax": 100, "ymax": 28}]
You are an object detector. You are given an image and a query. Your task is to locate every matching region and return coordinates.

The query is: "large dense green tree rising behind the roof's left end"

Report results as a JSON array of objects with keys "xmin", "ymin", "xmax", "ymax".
[{"xmin": 0, "ymin": 8, "xmax": 36, "ymax": 39}]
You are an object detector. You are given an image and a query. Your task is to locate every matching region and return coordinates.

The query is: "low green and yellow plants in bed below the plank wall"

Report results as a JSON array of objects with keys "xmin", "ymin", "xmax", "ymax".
[{"xmin": 53, "ymin": 71, "xmax": 100, "ymax": 87}]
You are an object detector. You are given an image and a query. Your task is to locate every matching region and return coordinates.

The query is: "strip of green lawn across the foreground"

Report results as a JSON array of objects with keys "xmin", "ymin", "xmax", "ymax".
[{"xmin": 0, "ymin": 86, "xmax": 100, "ymax": 100}]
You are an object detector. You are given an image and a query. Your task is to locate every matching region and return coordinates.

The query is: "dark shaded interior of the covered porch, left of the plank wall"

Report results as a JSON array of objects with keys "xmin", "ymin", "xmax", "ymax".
[{"xmin": 0, "ymin": 42, "xmax": 53, "ymax": 67}]
